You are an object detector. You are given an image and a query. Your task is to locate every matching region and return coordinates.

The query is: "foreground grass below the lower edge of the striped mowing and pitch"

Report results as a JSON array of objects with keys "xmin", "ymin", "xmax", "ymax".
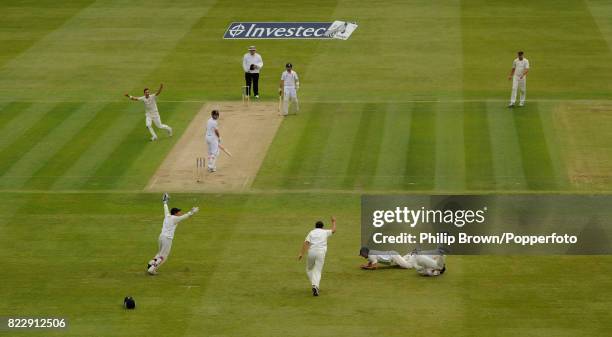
[{"xmin": 0, "ymin": 193, "xmax": 612, "ymax": 336}]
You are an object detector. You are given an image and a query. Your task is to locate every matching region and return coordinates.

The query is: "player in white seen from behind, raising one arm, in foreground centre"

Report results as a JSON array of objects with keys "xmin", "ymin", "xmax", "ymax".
[{"xmin": 298, "ymin": 217, "xmax": 336, "ymax": 296}]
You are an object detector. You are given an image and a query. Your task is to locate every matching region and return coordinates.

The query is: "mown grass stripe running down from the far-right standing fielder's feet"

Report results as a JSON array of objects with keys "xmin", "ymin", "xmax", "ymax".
[{"xmin": 512, "ymin": 102, "xmax": 557, "ymax": 190}]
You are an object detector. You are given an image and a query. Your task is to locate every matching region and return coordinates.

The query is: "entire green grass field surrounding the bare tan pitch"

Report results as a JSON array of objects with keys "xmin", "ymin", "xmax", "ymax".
[{"xmin": 0, "ymin": 0, "xmax": 612, "ymax": 336}]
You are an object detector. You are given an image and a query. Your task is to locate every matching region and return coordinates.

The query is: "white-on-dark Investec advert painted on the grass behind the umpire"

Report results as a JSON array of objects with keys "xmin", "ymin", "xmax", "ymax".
[{"xmin": 223, "ymin": 21, "xmax": 357, "ymax": 40}]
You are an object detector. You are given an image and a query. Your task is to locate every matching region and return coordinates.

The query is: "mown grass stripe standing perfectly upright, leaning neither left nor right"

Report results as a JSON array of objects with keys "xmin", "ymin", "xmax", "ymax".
[{"xmin": 432, "ymin": 103, "xmax": 465, "ymax": 191}]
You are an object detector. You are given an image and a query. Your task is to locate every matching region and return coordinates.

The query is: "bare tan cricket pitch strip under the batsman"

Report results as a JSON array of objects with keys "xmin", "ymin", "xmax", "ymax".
[{"xmin": 145, "ymin": 102, "xmax": 282, "ymax": 192}]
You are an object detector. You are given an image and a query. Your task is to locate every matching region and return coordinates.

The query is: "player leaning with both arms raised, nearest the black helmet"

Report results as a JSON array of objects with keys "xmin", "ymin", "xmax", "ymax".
[{"xmin": 147, "ymin": 193, "xmax": 200, "ymax": 275}]
